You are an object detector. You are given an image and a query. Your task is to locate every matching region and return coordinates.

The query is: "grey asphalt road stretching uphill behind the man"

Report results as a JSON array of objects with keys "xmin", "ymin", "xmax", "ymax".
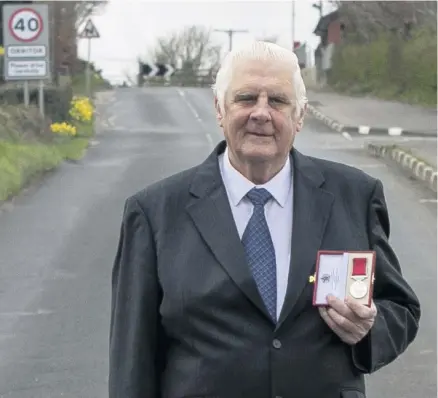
[{"xmin": 0, "ymin": 88, "xmax": 437, "ymax": 398}]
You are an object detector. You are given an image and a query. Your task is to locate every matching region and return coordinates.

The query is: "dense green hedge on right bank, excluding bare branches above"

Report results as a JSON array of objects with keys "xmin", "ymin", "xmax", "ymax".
[{"xmin": 328, "ymin": 28, "xmax": 437, "ymax": 105}]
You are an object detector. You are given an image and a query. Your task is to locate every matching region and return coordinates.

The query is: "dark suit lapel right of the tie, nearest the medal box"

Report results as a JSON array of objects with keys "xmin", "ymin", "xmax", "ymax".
[{"xmin": 277, "ymin": 150, "xmax": 334, "ymax": 328}]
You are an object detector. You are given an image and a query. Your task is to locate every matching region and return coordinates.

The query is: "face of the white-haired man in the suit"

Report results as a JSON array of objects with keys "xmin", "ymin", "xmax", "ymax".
[{"xmin": 216, "ymin": 62, "xmax": 301, "ymax": 163}]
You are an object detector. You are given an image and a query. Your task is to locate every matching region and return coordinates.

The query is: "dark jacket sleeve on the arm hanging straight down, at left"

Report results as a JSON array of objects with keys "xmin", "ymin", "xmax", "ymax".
[{"xmin": 109, "ymin": 197, "xmax": 161, "ymax": 398}]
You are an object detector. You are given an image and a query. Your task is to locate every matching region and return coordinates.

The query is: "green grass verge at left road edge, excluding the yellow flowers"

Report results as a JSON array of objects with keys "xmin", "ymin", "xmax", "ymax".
[{"xmin": 0, "ymin": 130, "xmax": 92, "ymax": 202}]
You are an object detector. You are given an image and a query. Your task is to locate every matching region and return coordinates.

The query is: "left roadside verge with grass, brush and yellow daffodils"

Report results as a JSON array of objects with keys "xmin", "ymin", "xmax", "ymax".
[{"xmin": 0, "ymin": 74, "xmax": 104, "ymax": 202}]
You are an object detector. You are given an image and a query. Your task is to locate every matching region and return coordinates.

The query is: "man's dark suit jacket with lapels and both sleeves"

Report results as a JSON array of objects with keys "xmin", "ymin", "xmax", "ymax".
[{"xmin": 109, "ymin": 142, "xmax": 420, "ymax": 398}]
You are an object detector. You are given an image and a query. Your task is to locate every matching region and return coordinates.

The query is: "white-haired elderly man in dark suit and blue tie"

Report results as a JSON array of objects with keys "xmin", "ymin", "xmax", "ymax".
[{"xmin": 109, "ymin": 42, "xmax": 420, "ymax": 398}]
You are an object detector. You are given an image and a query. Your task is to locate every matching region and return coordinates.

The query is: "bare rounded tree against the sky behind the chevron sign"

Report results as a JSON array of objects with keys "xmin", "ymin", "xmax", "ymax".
[{"xmin": 152, "ymin": 26, "xmax": 221, "ymax": 75}]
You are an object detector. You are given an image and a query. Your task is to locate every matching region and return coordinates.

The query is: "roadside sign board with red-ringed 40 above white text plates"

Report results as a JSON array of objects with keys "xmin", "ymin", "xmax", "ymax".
[{"xmin": 3, "ymin": 3, "xmax": 50, "ymax": 80}]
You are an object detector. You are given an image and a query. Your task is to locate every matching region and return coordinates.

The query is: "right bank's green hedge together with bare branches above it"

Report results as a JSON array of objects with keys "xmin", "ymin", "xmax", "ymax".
[{"xmin": 327, "ymin": 1, "xmax": 437, "ymax": 106}]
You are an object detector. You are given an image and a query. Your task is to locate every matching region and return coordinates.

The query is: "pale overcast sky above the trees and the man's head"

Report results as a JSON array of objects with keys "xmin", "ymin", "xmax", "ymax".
[{"xmin": 79, "ymin": 0, "xmax": 332, "ymax": 83}]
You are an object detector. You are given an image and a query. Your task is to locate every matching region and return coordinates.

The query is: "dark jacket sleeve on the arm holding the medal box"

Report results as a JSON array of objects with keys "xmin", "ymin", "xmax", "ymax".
[{"xmin": 352, "ymin": 180, "xmax": 420, "ymax": 373}]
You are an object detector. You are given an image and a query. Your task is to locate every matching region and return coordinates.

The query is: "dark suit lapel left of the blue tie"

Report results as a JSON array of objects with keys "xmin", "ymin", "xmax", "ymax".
[{"xmin": 187, "ymin": 142, "xmax": 270, "ymax": 318}]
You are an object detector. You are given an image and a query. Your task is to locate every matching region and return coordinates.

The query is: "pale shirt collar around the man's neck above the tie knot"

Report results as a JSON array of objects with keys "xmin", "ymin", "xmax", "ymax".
[{"xmin": 223, "ymin": 147, "xmax": 292, "ymax": 207}]
